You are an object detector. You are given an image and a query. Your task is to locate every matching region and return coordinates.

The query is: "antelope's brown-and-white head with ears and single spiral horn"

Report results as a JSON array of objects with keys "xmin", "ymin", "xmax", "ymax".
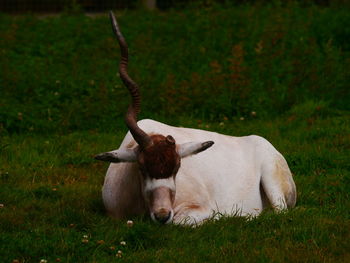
[{"xmin": 95, "ymin": 12, "xmax": 214, "ymax": 223}]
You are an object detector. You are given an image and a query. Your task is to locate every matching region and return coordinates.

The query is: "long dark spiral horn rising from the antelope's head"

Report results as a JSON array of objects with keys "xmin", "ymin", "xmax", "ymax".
[{"xmin": 109, "ymin": 11, "xmax": 152, "ymax": 148}]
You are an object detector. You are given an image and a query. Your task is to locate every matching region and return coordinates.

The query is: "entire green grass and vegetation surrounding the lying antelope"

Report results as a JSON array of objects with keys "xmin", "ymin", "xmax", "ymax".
[{"xmin": 0, "ymin": 1, "xmax": 350, "ymax": 262}]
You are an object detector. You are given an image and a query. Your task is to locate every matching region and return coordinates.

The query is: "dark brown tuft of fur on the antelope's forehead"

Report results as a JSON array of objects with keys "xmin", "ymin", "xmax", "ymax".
[{"xmin": 141, "ymin": 135, "xmax": 180, "ymax": 179}]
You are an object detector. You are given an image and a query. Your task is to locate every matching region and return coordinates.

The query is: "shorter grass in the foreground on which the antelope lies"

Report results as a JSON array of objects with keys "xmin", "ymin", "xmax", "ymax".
[{"xmin": 0, "ymin": 114, "xmax": 350, "ymax": 262}]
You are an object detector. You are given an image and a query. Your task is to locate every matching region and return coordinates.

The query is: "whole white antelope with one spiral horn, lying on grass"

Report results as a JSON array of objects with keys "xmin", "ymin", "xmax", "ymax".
[{"xmin": 95, "ymin": 12, "xmax": 296, "ymax": 224}]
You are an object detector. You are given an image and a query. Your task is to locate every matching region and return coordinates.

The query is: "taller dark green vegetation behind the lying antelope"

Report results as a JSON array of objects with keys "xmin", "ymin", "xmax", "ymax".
[{"xmin": 0, "ymin": 2, "xmax": 350, "ymax": 133}]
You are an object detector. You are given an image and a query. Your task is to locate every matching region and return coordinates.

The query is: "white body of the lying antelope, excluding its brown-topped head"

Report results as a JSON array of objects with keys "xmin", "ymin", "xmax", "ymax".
[{"xmin": 102, "ymin": 120, "xmax": 296, "ymax": 224}]
